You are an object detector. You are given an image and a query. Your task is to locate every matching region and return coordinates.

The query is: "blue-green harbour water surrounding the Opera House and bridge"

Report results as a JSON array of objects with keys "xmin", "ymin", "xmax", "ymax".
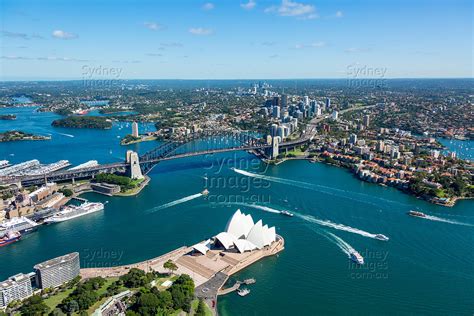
[{"xmin": 0, "ymin": 108, "xmax": 474, "ymax": 315}]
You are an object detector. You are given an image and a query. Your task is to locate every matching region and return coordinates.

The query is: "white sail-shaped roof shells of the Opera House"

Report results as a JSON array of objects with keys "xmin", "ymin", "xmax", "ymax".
[{"xmin": 215, "ymin": 210, "xmax": 276, "ymax": 253}]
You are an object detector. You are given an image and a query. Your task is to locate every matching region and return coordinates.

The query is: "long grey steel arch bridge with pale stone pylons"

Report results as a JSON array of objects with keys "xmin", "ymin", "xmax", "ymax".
[{"xmin": 0, "ymin": 130, "xmax": 311, "ymax": 186}]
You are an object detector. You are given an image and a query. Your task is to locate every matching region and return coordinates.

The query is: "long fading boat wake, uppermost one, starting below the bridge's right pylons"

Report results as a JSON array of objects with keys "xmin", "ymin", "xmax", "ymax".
[{"xmin": 231, "ymin": 168, "xmax": 406, "ymax": 207}]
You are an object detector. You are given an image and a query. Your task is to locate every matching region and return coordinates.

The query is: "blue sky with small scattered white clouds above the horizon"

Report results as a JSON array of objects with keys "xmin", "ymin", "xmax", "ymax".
[{"xmin": 0, "ymin": 0, "xmax": 473, "ymax": 80}]
